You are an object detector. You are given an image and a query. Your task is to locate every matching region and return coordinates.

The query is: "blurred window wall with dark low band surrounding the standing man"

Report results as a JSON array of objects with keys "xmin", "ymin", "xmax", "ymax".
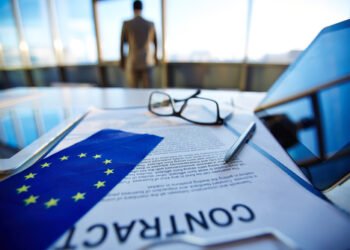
[{"xmin": 0, "ymin": 0, "xmax": 350, "ymax": 91}]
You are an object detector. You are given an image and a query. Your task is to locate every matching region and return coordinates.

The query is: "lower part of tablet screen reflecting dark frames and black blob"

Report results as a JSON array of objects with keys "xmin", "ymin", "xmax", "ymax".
[{"xmin": 258, "ymin": 80, "xmax": 350, "ymax": 191}]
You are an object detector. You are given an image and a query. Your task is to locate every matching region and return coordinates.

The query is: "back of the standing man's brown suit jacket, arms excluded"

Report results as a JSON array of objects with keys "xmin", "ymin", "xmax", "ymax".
[{"xmin": 122, "ymin": 16, "xmax": 155, "ymax": 69}]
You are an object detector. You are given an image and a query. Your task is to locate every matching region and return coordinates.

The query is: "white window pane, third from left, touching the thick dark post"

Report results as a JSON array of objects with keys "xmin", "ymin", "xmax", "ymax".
[{"xmin": 56, "ymin": 0, "xmax": 97, "ymax": 63}]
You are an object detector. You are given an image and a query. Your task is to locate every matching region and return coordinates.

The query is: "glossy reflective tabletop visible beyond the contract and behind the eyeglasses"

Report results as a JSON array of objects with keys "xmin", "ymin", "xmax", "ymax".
[{"xmin": 0, "ymin": 85, "xmax": 265, "ymax": 175}]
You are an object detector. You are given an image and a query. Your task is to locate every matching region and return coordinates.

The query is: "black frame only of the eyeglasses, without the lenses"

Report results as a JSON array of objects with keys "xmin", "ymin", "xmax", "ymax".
[{"xmin": 148, "ymin": 89, "xmax": 224, "ymax": 125}]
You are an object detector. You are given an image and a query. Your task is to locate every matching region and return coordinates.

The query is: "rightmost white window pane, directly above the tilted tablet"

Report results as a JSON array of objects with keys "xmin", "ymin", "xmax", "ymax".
[{"xmin": 248, "ymin": 0, "xmax": 350, "ymax": 63}]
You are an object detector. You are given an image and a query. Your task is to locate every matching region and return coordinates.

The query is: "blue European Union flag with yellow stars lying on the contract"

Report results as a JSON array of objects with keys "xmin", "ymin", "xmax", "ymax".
[{"xmin": 0, "ymin": 130, "xmax": 162, "ymax": 249}]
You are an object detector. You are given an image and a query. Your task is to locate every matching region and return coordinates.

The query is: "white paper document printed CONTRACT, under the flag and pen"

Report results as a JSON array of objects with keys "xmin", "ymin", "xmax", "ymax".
[{"xmin": 52, "ymin": 109, "xmax": 350, "ymax": 249}]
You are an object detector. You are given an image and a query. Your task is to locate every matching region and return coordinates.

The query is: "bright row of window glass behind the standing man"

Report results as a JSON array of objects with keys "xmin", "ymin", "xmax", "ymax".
[{"xmin": 0, "ymin": 0, "xmax": 350, "ymax": 67}]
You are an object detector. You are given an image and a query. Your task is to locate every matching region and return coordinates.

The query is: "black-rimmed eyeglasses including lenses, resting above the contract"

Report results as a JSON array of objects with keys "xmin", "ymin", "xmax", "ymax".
[{"xmin": 148, "ymin": 90, "xmax": 224, "ymax": 125}]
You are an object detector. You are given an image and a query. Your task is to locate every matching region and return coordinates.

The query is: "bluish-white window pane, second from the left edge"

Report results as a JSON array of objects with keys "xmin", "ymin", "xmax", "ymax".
[{"xmin": 18, "ymin": 0, "xmax": 55, "ymax": 65}]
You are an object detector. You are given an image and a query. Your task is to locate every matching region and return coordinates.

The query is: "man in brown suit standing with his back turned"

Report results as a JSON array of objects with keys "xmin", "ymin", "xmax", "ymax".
[{"xmin": 120, "ymin": 0, "xmax": 158, "ymax": 88}]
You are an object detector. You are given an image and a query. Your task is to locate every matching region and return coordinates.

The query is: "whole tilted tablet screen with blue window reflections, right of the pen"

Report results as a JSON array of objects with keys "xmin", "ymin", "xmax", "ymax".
[{"xmin": 256, "ymin": 20, "xmax": 350, "ymax": 191}]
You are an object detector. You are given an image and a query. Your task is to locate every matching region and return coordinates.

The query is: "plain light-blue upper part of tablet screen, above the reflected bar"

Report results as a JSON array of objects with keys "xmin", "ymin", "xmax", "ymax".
[{"xmin": 258, "ymin": 19, "xmax": 350, "ymax": 110}]
